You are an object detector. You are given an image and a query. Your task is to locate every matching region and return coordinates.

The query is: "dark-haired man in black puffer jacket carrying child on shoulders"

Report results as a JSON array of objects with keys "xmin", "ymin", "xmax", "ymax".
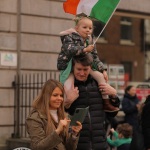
[{"xmin": 66, "ymin": 54, "xmax": 120, "ymax": 150}]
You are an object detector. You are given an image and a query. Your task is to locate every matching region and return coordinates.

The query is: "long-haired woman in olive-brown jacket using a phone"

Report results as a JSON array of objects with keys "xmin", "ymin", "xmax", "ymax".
[{"xmin": 26, "ymin": 80, "xmax": 82, "ymax": 150}]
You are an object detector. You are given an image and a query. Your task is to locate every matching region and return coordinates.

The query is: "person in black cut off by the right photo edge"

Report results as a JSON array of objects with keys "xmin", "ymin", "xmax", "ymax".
[{"xmin": 141, "ymin": 95, "xmax": 150, "ymax": 150}]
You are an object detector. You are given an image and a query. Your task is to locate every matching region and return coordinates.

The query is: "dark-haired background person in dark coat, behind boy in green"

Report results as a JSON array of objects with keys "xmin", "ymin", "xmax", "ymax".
[{"xmin": 122, "ymin": 85, "xmax": 144, "ymax": 150}]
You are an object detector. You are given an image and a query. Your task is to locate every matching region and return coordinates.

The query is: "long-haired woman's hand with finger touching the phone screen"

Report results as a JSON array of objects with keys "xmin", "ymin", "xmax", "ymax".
[{"xmin": 55, "ymin": 118, "xmax": 71, "ymax": 134}]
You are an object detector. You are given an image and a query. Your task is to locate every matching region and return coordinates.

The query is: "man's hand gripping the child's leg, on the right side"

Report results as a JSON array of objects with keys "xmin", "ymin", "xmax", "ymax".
[{"xmin": 99, "ymin": 83, "xmax": 117, "ymax": 98}]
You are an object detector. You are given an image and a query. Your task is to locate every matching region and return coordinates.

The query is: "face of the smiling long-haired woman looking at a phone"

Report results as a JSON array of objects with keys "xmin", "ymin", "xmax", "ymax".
[{"xmin": 50, "ymin": 87, "xmax": 63, "ymax": 110}]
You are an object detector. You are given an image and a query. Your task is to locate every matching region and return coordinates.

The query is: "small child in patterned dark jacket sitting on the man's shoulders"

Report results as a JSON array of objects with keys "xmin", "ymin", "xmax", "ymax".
[{"xmin": 57, "ymin": 14, "xmax": 119, "ymax": 112}]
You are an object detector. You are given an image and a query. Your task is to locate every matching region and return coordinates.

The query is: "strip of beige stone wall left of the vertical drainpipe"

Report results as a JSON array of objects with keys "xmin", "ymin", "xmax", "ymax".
[{"xmin": 0, "ymin": 0, "xmax": 17, "ymax": 146}]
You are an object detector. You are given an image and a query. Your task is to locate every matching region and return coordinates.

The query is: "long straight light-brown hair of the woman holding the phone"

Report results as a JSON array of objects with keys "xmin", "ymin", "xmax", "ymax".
[{"xmin": 32, "ymin": 79, "xmax": 66, "ymax": 134}]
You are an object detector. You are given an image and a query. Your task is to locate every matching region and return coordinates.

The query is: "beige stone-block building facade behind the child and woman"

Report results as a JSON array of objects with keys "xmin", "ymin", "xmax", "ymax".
[{"xmin": 0, "ymin": 0, "xmax": 150, "ymax": 147}]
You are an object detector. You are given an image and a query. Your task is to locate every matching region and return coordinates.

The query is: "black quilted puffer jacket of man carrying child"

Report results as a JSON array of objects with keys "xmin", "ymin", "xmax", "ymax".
[{"xmin": 66, "ymin": 76, "xmax": 120, "ymax": 150}]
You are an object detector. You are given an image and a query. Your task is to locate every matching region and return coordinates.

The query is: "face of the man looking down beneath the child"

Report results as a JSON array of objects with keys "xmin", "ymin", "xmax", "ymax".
[{"xmin": 73, "ymin": 63, "xmax": 91, "ymax": 81}]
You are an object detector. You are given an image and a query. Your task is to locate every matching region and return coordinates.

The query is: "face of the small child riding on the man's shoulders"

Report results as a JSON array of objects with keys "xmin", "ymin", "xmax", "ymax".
[{"xmin": 75, "ymin": 17, "xmax": 93, "ymax": 39}]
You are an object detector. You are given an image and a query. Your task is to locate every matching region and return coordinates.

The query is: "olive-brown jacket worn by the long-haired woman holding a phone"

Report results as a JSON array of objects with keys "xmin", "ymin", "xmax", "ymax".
[{"xmin": 26, "ymin": 110, "xmax": 78, "ymax": 150}]
